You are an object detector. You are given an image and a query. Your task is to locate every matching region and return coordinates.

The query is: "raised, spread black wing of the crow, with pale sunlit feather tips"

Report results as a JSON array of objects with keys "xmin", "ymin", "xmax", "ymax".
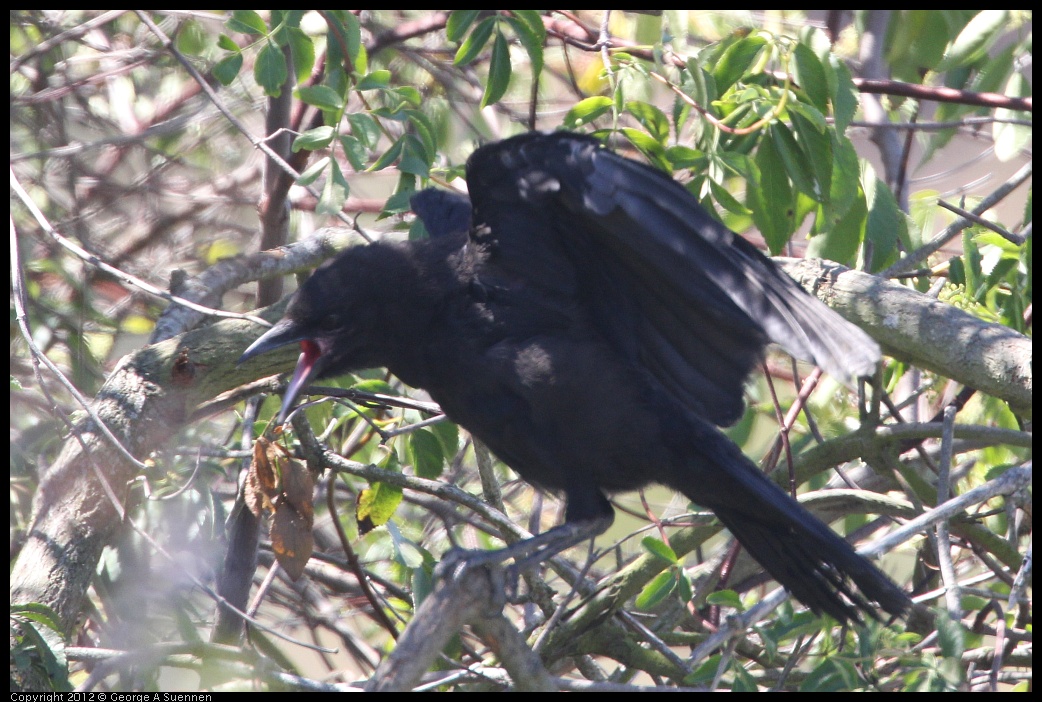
[{"xmin": 456, "ymin": 132, "xmax": 879, "ymax": 425}]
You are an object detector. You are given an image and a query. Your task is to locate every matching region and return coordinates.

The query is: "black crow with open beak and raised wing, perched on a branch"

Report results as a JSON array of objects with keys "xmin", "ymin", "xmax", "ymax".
[{"xmin": 242, "ymin": 132, "xmax": 909, "ymax": 621}]
